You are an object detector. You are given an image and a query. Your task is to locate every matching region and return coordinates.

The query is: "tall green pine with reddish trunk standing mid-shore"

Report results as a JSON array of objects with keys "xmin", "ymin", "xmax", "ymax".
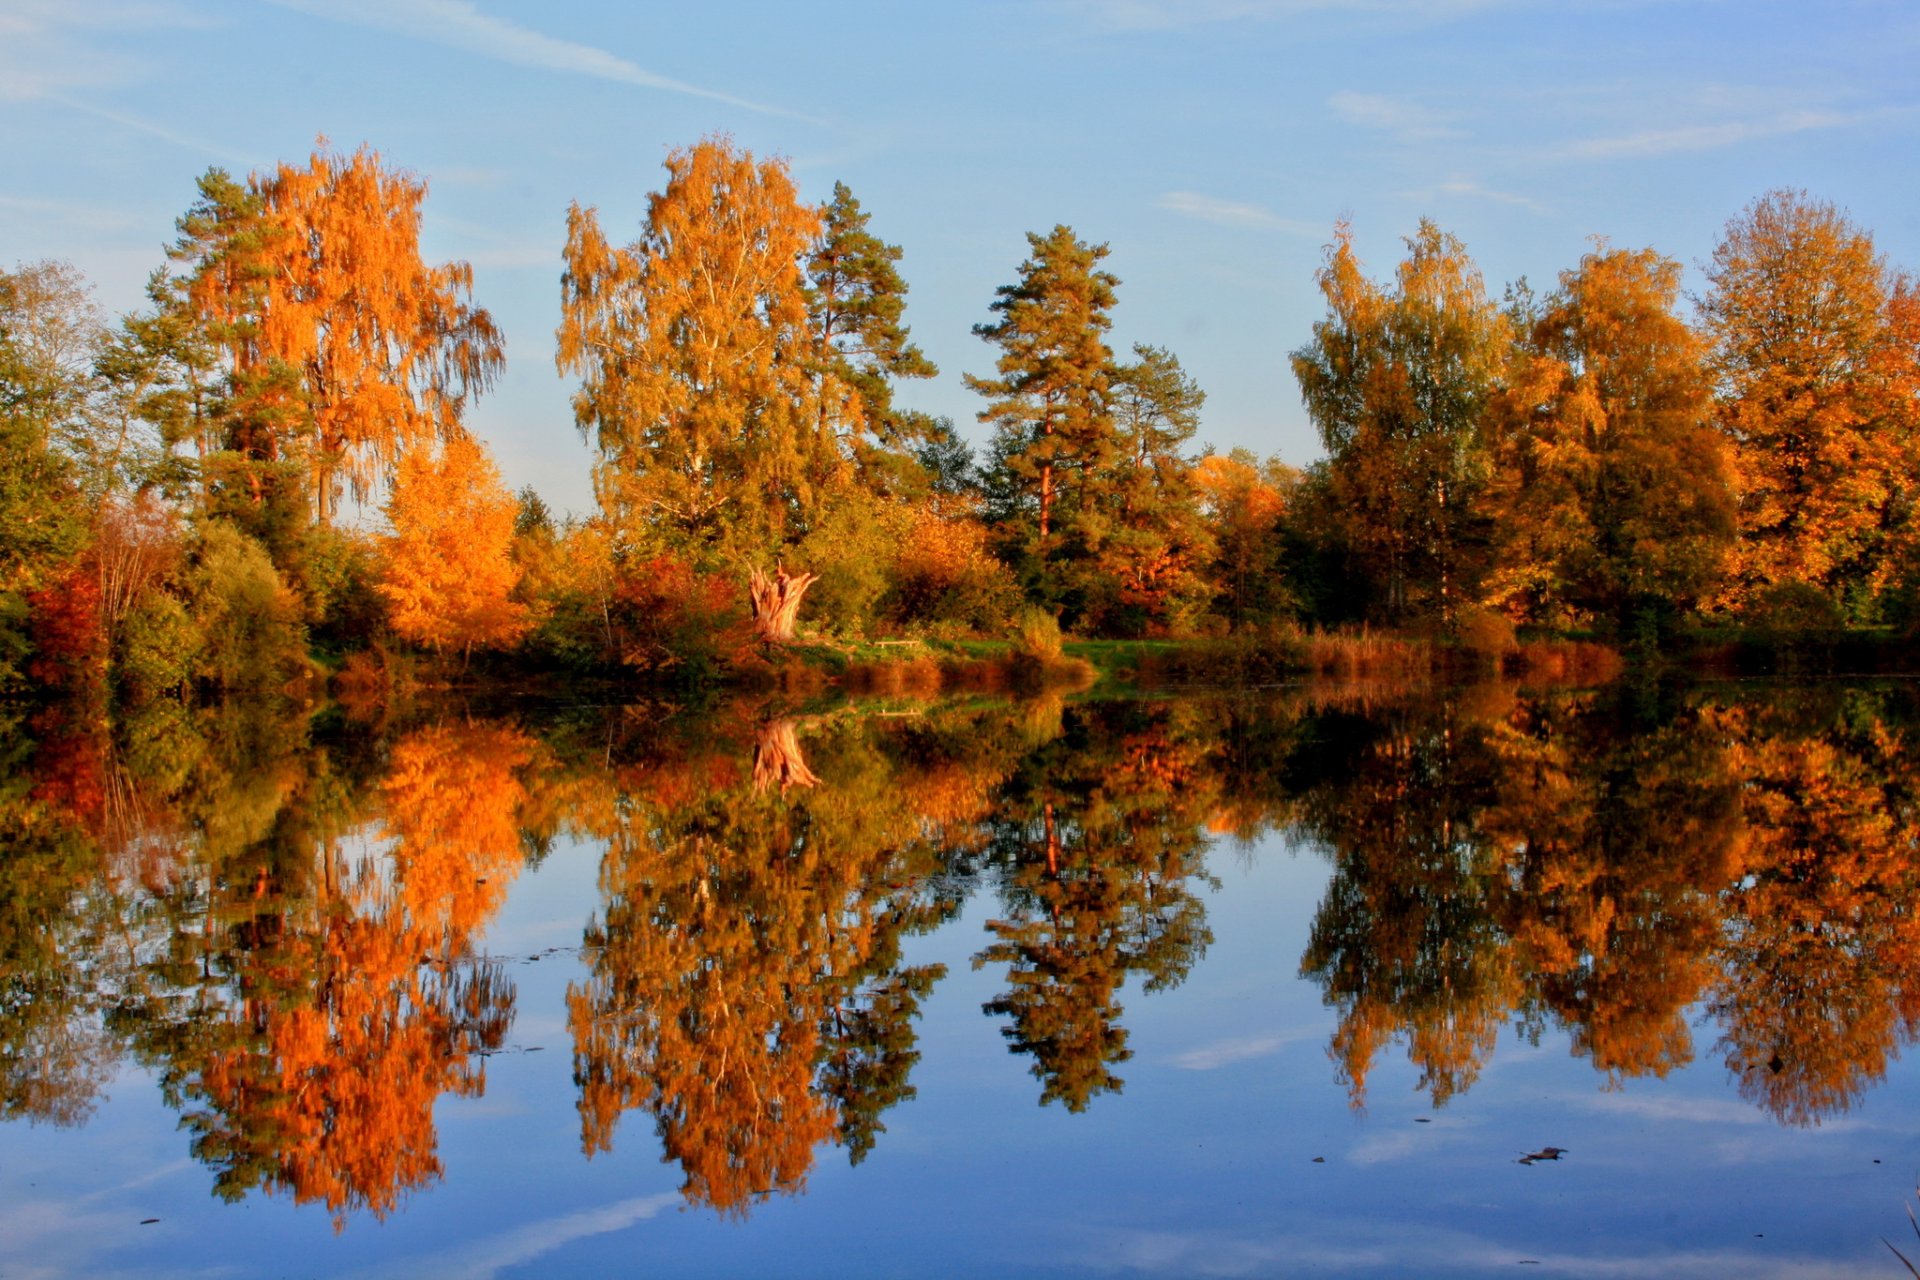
[{"xmin": 966, "ymin": 226, "xmax": 1119, "ymax": 587}]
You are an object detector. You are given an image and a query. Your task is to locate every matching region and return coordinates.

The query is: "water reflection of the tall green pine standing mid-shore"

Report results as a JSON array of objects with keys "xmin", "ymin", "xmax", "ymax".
[{"xmin": 973, "ymin": 708, "xmax": 1212, "ymax": 1111}]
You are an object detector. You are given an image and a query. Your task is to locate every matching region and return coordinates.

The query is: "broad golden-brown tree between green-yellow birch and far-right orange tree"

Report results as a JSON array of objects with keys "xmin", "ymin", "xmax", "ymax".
[{"xmin": 1488, "ymin": 244, "xmax": 1734, "ymax": 624}]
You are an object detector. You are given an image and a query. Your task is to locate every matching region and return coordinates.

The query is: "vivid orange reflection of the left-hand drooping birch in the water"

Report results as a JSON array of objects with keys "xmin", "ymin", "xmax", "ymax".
[{"xmin": 125, "ymin": 725, "xmax": 530, "ymax": 1221}]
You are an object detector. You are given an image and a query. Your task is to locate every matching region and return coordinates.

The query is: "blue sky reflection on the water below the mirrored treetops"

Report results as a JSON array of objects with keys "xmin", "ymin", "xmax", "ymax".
[{"xmin": 0, "ymin": 825, "xmax": 1920, "ymax": 1280}]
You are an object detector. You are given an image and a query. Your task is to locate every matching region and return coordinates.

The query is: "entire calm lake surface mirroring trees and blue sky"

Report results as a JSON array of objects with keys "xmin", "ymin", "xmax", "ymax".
[{"xmin": 0, "ymin": 685, "xmax": 1920, "ymax": 1278}]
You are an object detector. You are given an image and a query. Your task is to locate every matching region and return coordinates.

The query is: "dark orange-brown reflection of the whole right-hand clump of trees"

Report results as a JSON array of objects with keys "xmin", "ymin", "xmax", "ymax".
[{"xmin": 1290, "ymin": 679, "xmax": 1920, "ymax": 1123}]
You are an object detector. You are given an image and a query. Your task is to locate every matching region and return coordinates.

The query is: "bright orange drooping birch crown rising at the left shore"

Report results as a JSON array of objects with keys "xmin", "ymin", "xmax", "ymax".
[{"xmin": 154, "ymin": 144, "xmax": 505, "ymax": 526}]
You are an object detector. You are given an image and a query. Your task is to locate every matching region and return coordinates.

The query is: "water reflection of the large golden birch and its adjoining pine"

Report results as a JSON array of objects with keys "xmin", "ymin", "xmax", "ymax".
[{"xmin": 568, "ymin": 725, "xmax": 954, "ymax": 1211}]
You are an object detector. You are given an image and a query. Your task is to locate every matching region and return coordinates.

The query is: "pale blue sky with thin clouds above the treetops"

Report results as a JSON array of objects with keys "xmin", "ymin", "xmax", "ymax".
[{"xmin": 0, "ymin": 0, "xmax": 1920, "ymax": 514}]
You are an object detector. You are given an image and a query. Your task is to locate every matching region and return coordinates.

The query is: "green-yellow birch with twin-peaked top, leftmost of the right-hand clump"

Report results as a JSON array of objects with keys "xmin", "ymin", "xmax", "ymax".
[{"xmin": 1292, "ymin": 221, "xmax": 1507, "ymax": 624}]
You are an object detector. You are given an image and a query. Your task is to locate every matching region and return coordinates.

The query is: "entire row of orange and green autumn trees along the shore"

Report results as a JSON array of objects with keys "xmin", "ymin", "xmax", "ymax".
[{"xmin": 0, "ymin": 138, "xmax": 1920, "ymax": 699}]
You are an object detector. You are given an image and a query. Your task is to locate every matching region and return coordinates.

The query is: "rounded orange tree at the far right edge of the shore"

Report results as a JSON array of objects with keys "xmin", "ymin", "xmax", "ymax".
[{"xmin": 1701, "ymin": 188, "xmax": 1916, "ymax": 612}]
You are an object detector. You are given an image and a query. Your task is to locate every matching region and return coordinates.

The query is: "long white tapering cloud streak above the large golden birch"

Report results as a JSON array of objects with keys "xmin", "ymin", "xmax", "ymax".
[{"xmin": 275, "ymin": 0, "xmax": 818, "ymax": 123}]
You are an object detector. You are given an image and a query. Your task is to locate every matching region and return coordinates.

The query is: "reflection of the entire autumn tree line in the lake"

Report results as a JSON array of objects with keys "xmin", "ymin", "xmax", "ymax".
[{"xmin": 11, "ymin": 687, "xmax": 1920, "ymax": 1222}]
